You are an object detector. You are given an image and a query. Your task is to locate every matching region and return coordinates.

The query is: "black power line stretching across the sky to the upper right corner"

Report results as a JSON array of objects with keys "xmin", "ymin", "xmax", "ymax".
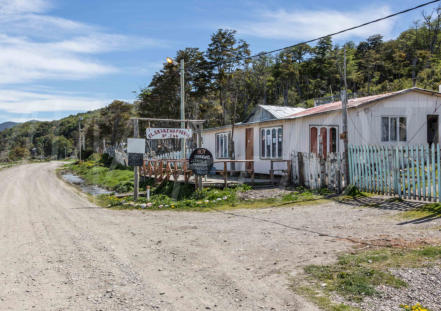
[{"xmin": 232, "ymin": 0, "xmax": 441, "ymax": 63}]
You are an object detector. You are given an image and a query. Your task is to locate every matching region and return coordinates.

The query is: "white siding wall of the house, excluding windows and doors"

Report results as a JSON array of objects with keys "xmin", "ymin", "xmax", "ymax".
[{"xmin": 202, "ymin": 92, "xmax": 441, "ymax": 174}]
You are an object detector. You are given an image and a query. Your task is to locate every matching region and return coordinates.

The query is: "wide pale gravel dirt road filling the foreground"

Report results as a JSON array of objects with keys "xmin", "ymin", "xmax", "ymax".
[{"xmin": 0, "ymin": 163, "xmax": 440, "ymax": 311}]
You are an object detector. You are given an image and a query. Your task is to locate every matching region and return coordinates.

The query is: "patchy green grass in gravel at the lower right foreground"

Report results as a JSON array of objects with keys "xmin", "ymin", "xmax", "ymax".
[{"xmin": 304, "ymin": 246, "xmax": 441, "ymax": 302}]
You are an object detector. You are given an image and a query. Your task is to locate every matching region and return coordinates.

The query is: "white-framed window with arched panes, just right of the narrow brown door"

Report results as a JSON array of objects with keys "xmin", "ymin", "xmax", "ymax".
[{"xmin": 259, "ymin": 125, "xmax": 284, "ymax": 160}]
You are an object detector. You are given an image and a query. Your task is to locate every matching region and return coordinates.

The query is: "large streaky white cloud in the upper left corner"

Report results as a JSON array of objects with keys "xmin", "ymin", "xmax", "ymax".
[{"xmin": 0, "ymin": 0, "xmax": 163, "ymax": 85}]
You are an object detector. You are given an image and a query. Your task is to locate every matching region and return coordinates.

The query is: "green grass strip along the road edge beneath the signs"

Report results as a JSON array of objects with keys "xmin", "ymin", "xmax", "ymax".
[{"xmin": 63, "ymin": 155, "xmax": 329, "ymax": 211}]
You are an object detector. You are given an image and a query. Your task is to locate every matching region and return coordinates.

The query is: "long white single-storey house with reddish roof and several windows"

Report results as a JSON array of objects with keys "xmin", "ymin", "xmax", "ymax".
[{"xmin": 202, "ymin": 88, "xmax": 441, "ymax": 174}]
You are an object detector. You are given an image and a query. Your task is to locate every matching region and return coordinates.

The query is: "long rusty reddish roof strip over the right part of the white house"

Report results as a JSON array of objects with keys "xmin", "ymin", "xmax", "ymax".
[{"xmin": 288, "ymin": 88, "xmax": 441, "ymax": 118}]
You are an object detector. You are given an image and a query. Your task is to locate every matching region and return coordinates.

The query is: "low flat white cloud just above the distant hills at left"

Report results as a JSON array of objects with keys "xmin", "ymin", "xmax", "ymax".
[{"xmin": 0, "ymin": 89, "xmax": 111, "ymax": 114}]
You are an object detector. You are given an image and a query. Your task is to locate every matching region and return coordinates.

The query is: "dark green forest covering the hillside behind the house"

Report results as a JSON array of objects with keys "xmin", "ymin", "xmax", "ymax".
[{"xmin": 0, "ymin": 8, "xmax": 441, "ymax": 160}]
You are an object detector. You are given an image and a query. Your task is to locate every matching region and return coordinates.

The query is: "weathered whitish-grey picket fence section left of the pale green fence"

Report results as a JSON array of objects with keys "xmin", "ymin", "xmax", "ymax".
[{"xmin": 291, "ymin": 152, "xmax": 347, "ymax": 192}]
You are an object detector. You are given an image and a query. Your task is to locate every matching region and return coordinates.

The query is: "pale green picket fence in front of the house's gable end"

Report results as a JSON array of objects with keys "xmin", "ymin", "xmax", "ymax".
[{"xmin": 349, "ymin": 144, "xmax": 441, "ymax": 202}]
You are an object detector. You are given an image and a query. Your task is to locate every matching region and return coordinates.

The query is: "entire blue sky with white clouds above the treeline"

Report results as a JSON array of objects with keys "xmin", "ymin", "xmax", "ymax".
[{"xmin": 0, "ymin": 0, "xmax": 436, "ymax": 123}]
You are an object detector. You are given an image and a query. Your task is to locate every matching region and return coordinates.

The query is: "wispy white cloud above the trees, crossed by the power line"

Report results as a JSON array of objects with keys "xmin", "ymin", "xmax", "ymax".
[{"xmin": 232, "ymin": 6, "xmax": 393, "ymax": 40}]
